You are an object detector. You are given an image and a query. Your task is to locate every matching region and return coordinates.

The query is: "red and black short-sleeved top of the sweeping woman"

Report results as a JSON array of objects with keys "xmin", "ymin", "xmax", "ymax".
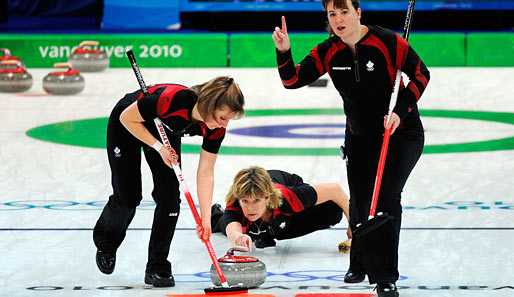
[{"xmin": 122, "ymin": 84, "xmax": 226, "ymax": 154}]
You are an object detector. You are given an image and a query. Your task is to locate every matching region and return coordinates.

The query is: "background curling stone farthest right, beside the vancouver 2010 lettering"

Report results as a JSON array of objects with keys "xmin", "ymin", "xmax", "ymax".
[{"xmin": 68, "ymin": 40, "xmax": 109, "ymax": 72}]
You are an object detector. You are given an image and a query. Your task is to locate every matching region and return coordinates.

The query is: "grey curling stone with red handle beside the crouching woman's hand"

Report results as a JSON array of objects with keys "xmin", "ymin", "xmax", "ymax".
[{"xmin": 211, "ymin": 246, "xmax": 267, "ymax": 288}]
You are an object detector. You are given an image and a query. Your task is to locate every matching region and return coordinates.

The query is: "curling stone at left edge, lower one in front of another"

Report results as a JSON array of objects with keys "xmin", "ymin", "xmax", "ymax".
[{"xmin": 0, "ymin": 60, "xmax": 32, "ymax": 93}]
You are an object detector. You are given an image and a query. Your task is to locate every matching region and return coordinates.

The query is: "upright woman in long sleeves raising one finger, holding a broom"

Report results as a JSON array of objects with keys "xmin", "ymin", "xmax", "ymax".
[{"xmin": 273, "ymin": 0, "xmax": 430, "ymax": 296}]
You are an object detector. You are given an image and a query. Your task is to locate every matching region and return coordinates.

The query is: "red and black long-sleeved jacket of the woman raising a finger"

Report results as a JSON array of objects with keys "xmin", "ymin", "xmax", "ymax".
[{"xmin": 277, "ymin": 25, "xmax": 430, "ymax": 137}]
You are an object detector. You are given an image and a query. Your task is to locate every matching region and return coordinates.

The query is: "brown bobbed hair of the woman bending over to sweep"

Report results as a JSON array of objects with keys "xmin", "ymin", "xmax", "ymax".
[{"xmin": 189, "ymin": 76, "xmax": 245, "ymax": 121}]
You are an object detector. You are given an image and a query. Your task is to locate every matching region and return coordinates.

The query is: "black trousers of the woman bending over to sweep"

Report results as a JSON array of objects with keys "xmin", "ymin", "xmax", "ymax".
[{"xmin": 93, "ymin": 108, "xmax": 181, "ymax": 273}]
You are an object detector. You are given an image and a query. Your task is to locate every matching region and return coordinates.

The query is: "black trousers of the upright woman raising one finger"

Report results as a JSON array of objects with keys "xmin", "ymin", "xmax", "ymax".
[{"xmin": 345, "ymin": 123, "xmax": 424, "ymax": 284}]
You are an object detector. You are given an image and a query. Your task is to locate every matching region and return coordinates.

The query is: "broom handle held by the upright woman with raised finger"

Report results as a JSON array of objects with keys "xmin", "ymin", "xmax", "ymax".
[{"xmin": 368, "ymin": 0, "xmax": 416, "ymax": 220}]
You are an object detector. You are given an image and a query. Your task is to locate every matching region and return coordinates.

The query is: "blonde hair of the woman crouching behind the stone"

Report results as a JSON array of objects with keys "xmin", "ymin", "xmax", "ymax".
[{"xmin": 225, "ymin": 166, "xmax": 282, "ymax": 209}]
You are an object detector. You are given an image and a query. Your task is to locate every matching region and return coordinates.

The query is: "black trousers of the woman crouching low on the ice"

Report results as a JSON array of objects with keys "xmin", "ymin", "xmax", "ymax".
[{"xmin": 211, "ymin": 201, "xmax": 343, "ymax": 240}]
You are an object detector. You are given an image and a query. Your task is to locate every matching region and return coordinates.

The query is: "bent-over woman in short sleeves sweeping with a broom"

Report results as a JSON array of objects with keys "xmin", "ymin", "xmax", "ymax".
[{"xmin": 93, "ymin": 76, "xmax": 244, "ymax": 287}]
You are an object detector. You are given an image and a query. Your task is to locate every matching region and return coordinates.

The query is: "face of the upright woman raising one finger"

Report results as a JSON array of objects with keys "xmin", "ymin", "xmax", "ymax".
[{"xmin": 327, "ymin": 0, "xmax": 361, "ymax": 41}]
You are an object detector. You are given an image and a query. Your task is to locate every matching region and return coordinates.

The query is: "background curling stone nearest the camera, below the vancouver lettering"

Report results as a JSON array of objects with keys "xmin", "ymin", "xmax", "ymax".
[{"xmin": 43, "ymin": 63, "xmax": 85, "ymax": 95}]
